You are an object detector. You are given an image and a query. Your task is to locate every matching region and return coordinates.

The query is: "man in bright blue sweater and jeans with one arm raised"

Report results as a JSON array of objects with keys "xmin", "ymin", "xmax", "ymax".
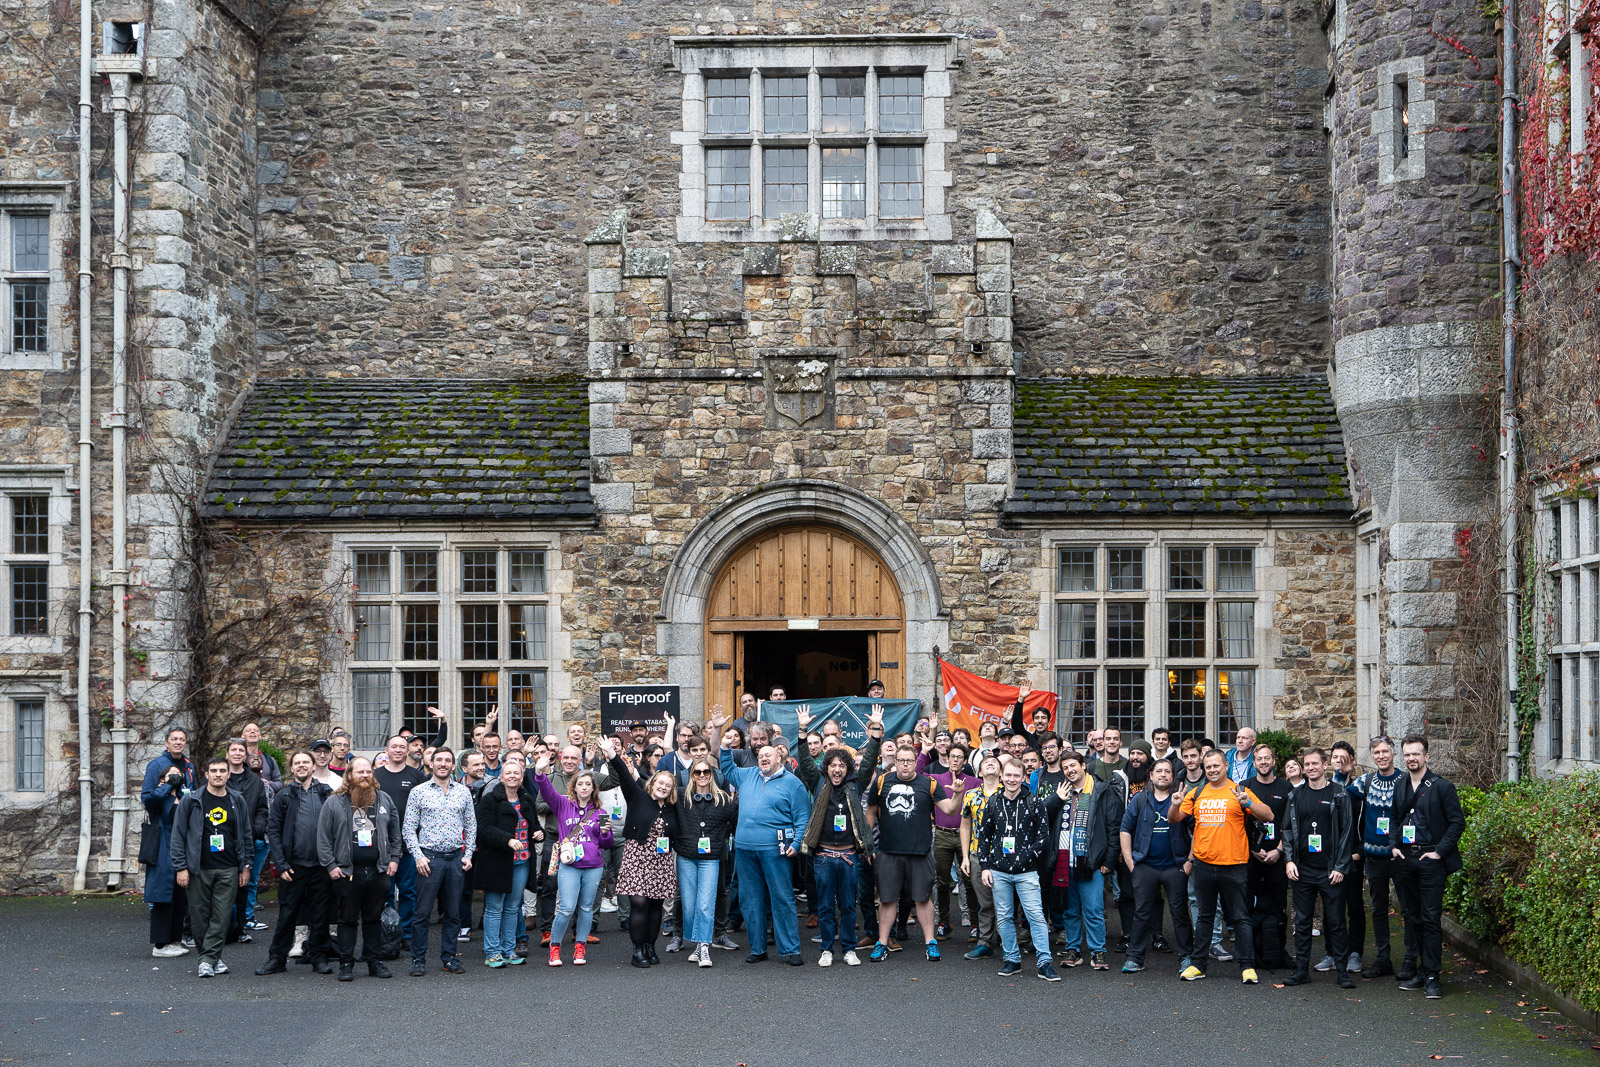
[{"xmin": 706, "ymin": 704, "xmax": 811, "ymax": 966}]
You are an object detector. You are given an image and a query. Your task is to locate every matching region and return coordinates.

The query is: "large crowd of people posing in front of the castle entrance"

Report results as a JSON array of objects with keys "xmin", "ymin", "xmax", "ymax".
[{"xmin": 141, "ymin": 681, "xmax": 1464, "ymax": 998}]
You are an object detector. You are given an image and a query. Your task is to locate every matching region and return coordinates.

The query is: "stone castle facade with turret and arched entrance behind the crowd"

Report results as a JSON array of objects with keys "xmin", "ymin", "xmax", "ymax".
[{"xmin": 0, "ymin": 0, "xmax": 1594, "ymax": 891}]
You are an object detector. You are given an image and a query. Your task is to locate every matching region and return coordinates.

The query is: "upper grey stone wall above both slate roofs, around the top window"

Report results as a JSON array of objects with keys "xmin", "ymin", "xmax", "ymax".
[{"xmin": 259, "ymin": 0, "xmax": 1328, "ymax": 374}]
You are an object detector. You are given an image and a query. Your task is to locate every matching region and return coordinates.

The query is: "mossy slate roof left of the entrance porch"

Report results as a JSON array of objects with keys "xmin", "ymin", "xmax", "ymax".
[{"xmin": 203, "ymin": 378, "xmax": 595, "ymax": 522}]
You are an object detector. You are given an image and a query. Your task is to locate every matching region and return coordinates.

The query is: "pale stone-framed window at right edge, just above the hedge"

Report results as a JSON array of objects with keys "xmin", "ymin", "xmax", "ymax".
[{"xmin": 1534, "ymin": 483, "xmax": 1600, "ymax": 768}]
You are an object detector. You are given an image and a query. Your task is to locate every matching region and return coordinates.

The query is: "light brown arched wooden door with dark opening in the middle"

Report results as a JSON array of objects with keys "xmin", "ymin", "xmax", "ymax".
[{"xmin": 706, "ymin": 526, "xmax": 906, "ymax": 713}]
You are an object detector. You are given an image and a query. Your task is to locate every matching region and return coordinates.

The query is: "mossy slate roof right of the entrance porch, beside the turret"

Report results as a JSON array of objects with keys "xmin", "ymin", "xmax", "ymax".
[{"xmin": 1005, "ymin": 374, "xmax": 1354, "ymax": 518}]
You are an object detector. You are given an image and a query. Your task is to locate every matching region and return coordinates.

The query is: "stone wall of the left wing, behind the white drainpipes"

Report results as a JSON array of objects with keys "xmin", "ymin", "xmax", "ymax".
[{"xmin": 0, "ymin": 0, "xmax": 256, "ymax": 891}]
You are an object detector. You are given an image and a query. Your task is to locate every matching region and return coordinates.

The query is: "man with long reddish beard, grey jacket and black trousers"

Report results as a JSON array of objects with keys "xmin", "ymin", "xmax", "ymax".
[{"xmin": 317, "ymin": 757, "xmax": 403, "ymax": 982}]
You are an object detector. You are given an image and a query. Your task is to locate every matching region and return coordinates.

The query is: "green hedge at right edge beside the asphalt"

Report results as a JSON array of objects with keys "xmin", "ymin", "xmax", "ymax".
[{"xmin": 1445, "ymin": 773, "xmax": 1600, "ymax": 1011}]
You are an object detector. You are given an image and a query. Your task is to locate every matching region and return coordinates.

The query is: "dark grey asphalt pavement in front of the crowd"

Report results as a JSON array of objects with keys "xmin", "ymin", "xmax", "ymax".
[{"xmin": 0, "ymin": 897, "xmax": 1600, "ymax": 1067}]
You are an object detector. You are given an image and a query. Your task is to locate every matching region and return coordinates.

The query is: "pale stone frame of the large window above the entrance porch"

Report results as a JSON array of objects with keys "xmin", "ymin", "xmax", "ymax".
[{"xmin": 672, "ymin": 34, "xmax": 962, "ymax": 243}]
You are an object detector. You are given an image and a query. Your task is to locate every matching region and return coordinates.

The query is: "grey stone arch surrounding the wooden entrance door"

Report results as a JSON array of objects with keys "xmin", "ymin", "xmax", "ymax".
[{"xmin": 656, "ymin": 478, "xmax": 949, "ymax": 715}]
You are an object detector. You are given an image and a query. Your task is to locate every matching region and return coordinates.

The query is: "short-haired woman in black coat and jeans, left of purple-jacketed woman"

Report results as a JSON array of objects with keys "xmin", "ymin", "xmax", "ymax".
[{"xmin": 472, "ymin": 757, "xmax": 544, "ymax": 968}]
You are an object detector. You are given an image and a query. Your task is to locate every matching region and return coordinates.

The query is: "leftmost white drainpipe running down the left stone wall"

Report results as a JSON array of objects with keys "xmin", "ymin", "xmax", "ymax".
[{"xmin": 72, "ymin": 0, "xmax": 94, "ymax": 893}]
